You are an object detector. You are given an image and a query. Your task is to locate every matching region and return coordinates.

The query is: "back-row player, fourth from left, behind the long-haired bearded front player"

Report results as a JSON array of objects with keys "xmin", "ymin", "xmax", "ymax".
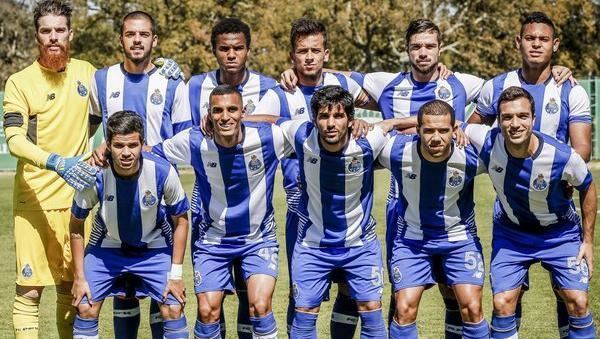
[{"xmin": 255, "ymin": 18, "xmax": 373, "ymax": 338}]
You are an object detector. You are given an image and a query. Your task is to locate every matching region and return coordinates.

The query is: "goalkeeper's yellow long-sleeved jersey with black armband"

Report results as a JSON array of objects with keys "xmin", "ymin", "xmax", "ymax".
[{"xmin": 4, "ymin": 58, "xmax": 95, "ymax": 210}]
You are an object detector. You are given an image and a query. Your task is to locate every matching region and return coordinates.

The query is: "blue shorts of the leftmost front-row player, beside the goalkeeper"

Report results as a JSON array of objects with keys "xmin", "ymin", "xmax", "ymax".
[{"xmin": 82, "ymin": 246, "xmax": 179, "ymax": 304}]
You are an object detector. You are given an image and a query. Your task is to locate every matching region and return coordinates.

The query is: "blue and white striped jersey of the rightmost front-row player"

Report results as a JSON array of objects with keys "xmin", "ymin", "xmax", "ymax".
[{"xmin": 465, "ymin": 124, "xmax": 592, "ymax": 232}]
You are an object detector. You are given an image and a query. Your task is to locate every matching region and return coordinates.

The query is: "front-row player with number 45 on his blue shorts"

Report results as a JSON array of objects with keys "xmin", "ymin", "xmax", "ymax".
[{"xmin": 153, "ymin": 85, "xmax": 284, "ymax": 338}]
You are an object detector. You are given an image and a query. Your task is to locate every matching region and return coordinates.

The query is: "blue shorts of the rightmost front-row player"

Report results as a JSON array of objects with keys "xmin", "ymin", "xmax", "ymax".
[{"xmin": 490, "ymin": 223, "xmax": 589, "ymax": 294}]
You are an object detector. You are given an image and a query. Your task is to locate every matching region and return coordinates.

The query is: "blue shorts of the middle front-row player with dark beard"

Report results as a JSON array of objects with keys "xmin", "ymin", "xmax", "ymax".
[{"xmin": 292, "ymin": 239, "xmax": 383, "ymax": 308}]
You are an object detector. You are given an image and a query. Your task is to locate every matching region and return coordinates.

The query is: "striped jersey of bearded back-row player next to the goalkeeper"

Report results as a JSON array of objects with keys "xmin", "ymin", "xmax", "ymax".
[{"xmin": 90, "ymin": 64, "xmax": 192, "ymax": 145}]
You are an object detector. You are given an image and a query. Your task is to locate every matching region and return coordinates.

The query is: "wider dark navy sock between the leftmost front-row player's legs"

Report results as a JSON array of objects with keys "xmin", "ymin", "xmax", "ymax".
[{"xmin": 113, "ymin": 298, "xmax": 141, "ymax": 339}]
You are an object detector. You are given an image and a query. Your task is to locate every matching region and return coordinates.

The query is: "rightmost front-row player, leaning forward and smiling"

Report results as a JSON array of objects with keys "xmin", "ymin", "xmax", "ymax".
[{"xmin": 466, "ymin": 87, "xmax": 596, "ymax": 338}]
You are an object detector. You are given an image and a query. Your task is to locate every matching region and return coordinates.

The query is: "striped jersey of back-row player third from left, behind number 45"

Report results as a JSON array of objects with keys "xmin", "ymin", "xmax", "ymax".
[{"xmin": 188, "ymin": 70, "xmax": 277, "ymax": 126}]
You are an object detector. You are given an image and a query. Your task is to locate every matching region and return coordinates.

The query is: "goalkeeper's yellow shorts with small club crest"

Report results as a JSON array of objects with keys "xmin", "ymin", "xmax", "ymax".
[{"xmin": 14, "ymin": 208, "xmax": 91, "ymax": 286}]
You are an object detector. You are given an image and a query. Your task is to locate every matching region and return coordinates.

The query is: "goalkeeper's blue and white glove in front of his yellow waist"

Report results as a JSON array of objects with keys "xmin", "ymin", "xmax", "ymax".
[{"xmin": 46, "ymin": 153, "xmax": 96, "ymax": 191}]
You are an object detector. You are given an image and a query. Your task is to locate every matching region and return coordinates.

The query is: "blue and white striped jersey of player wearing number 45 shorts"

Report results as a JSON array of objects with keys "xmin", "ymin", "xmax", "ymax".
[{"xmin": 153, "ymin": 122, "xmax": 289, "ymax": 245}]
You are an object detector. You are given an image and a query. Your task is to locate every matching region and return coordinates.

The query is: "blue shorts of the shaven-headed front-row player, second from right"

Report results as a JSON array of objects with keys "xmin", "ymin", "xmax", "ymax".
[{"xmin": 388, "ymin": 239, "xmax": 485, "ymax": 292}]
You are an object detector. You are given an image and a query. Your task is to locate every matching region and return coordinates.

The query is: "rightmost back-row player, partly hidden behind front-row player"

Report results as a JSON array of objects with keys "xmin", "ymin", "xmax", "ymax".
[{"xmin": 469, "ymin": 12, "xmax": 592, "ymax": 338}]
